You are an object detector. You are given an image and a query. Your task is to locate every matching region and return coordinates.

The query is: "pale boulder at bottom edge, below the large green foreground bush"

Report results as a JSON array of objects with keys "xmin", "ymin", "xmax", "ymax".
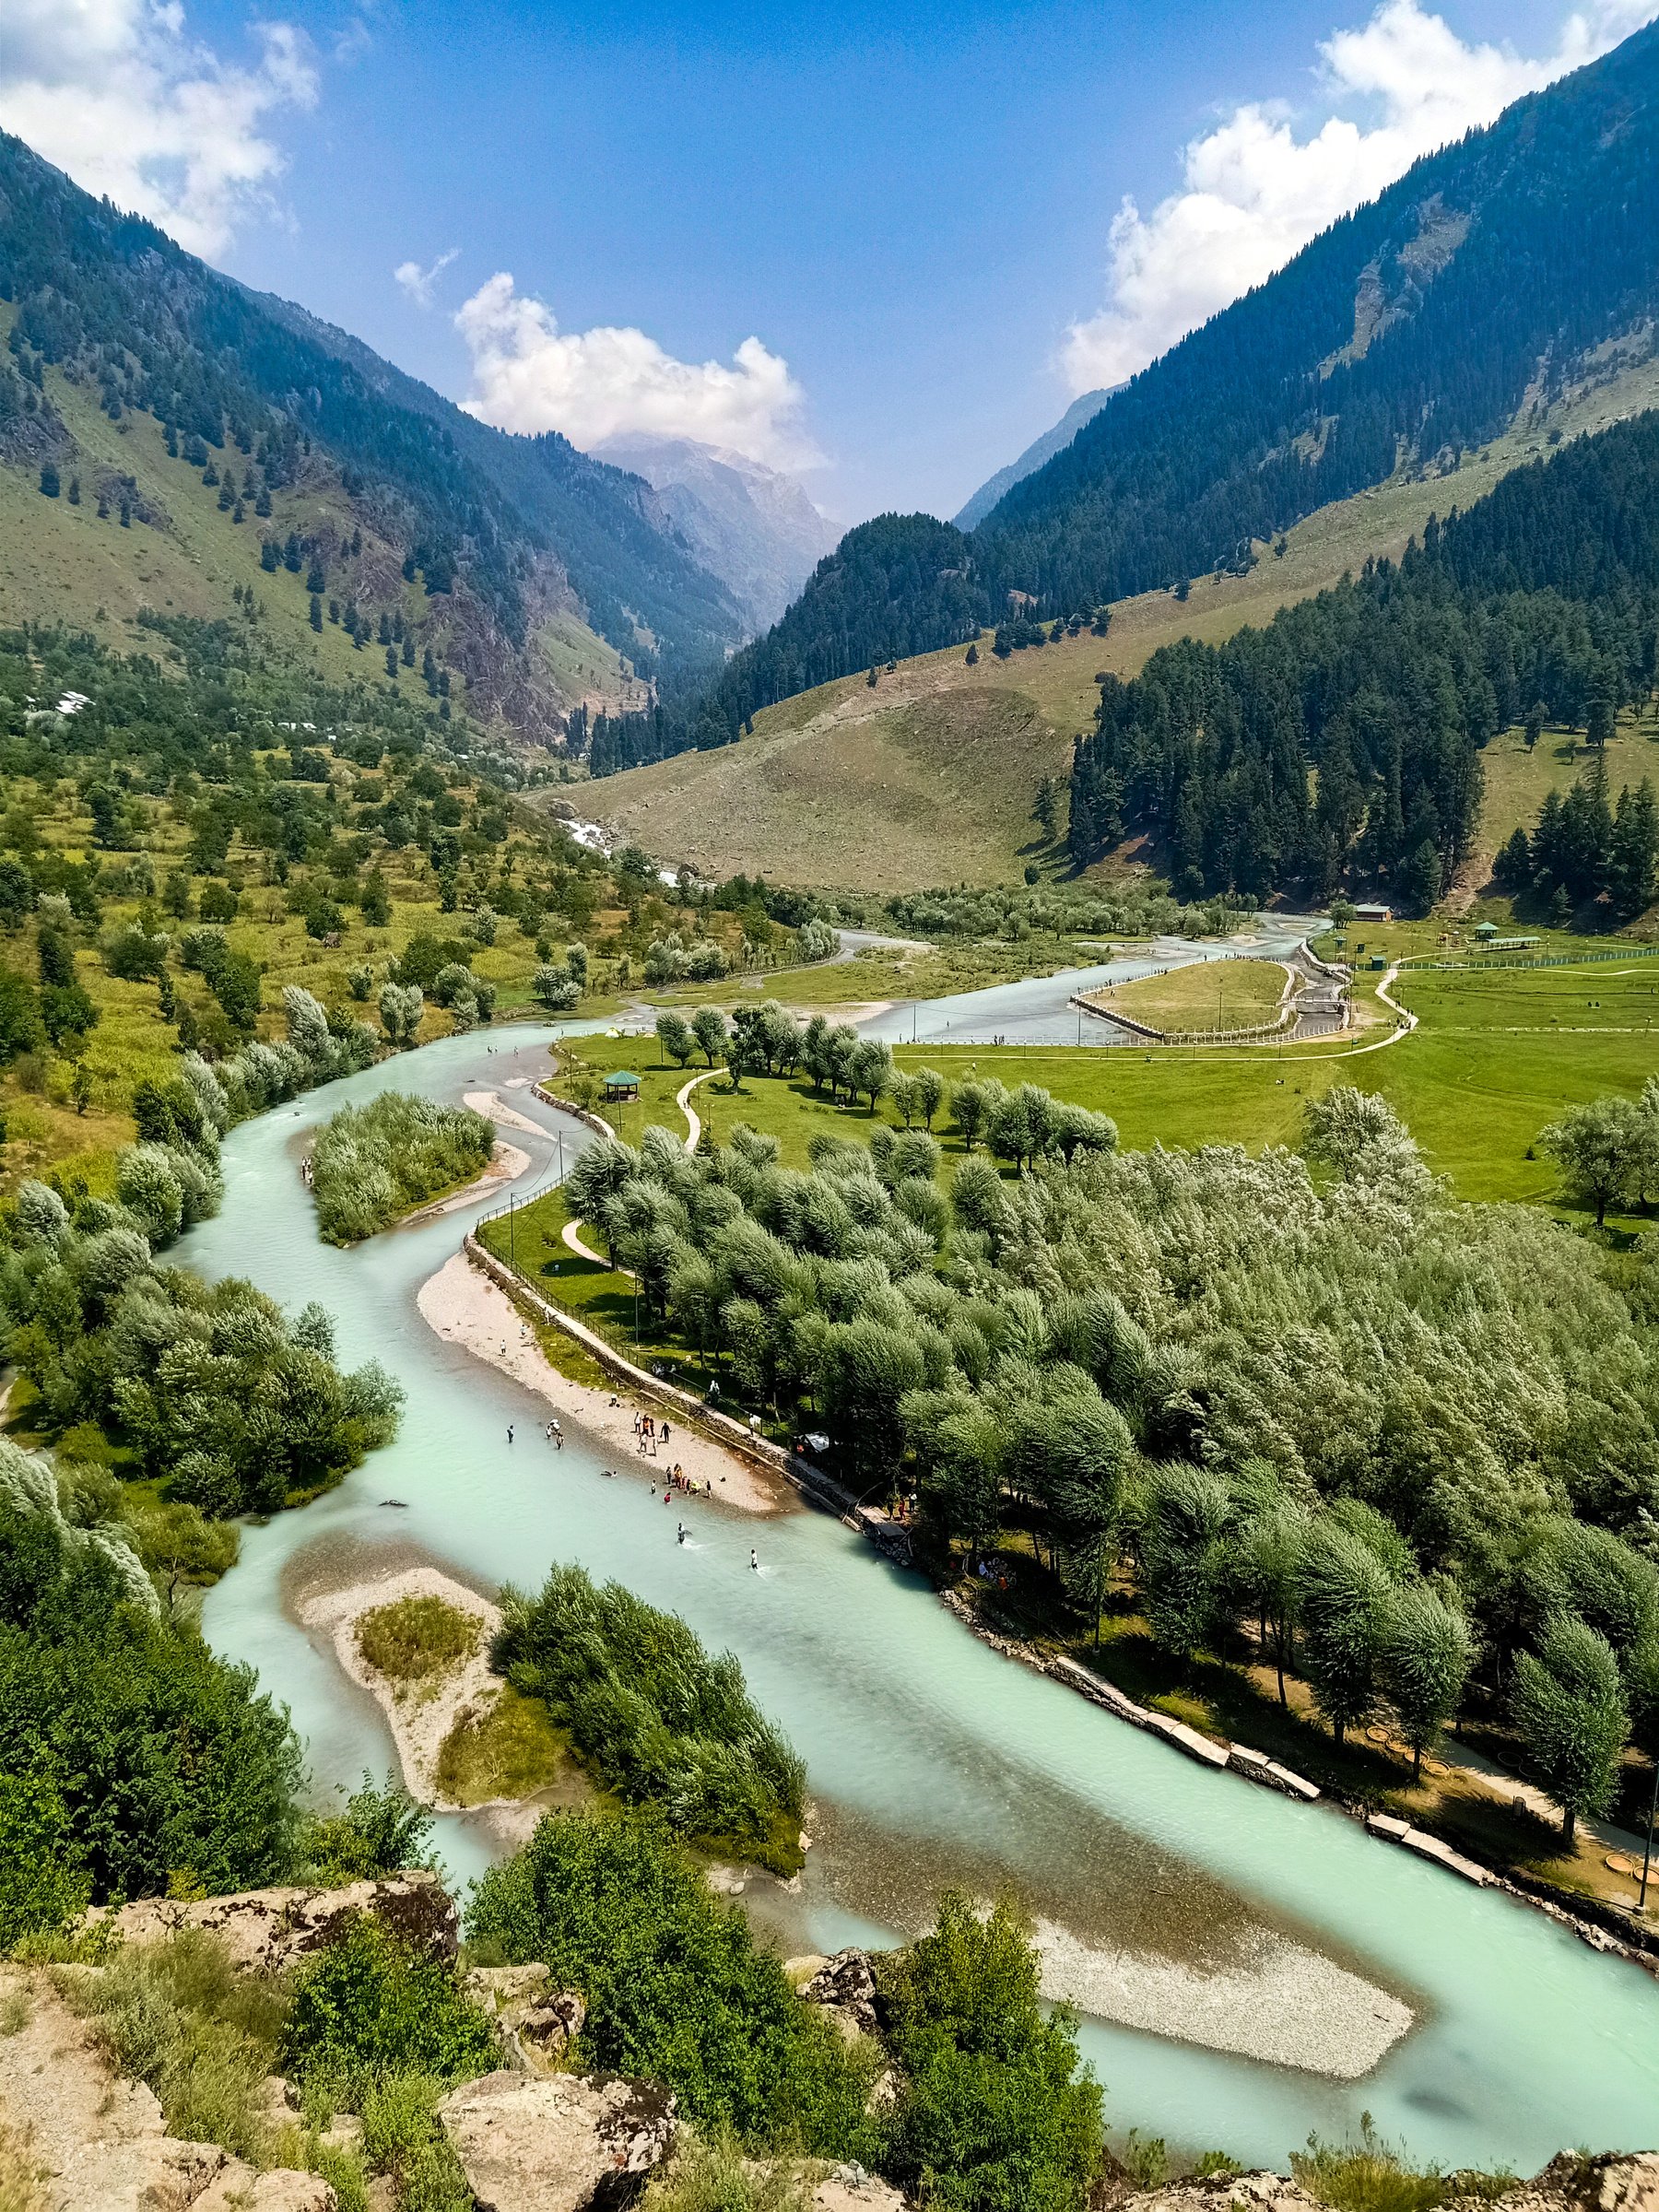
[{"xmin": 438, "ymin": 2070, "xmax": 675, "ymax": 2212}]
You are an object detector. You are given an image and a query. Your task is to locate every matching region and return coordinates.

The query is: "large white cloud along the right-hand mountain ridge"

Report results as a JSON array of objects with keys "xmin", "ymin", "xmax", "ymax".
[{"xmin": 1062, "ymin": 0, "xmax": 1657, "ymax": 394}]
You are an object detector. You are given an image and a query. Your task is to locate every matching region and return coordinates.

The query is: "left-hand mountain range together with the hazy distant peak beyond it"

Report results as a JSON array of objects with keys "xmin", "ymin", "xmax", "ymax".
[{"xmin": 0, "ymin": 133, "xmax": 818, "ymax": 739}]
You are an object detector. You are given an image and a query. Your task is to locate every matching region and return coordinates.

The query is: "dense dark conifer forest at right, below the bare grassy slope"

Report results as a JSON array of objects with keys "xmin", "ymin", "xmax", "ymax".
[{"xmin": 1071, "ymin": 414, "xmax": 1659, "ymax": 909}]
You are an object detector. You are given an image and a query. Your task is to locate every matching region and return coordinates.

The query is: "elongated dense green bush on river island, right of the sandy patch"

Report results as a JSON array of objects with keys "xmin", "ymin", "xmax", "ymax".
[{"xmin": 493, "ymin": 1566, "xmax": 806, "ymax": 1874}]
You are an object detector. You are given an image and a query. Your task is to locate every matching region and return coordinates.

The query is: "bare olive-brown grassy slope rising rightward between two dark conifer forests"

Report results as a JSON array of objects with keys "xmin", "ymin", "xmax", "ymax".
[{"xmin": 582, "ymin": 345, "xmax": 1659, "ymax": 891}]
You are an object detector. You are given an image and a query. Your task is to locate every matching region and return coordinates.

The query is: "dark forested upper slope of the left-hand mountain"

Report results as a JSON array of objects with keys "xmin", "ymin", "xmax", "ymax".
[{"xmin": 0, "ymin": 133, "xmax": 743, "ymax": 728}]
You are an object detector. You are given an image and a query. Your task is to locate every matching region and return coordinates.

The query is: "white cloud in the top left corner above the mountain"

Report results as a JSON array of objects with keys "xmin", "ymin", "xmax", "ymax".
[{"xmin": 0, "ymin": 0, "xmax": 316, "ymax": 254}]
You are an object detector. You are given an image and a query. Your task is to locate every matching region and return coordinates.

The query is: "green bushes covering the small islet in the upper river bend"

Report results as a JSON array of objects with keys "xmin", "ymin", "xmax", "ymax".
[{"xmin": 312, "ymin": 1090, "xmax": 496, "ymax": 1243}]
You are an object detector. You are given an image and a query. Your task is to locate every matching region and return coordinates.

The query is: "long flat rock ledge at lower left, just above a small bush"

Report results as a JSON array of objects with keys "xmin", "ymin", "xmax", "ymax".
[{"xmin": 87, "ymin": 1874, "xmax": 458, "ymax": 1973}]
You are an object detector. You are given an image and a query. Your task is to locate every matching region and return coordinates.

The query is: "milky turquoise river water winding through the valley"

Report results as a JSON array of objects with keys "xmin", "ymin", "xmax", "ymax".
[{"xmin": 182, "ymin": 1029, "xmax": 1659, "ymax": 2170}]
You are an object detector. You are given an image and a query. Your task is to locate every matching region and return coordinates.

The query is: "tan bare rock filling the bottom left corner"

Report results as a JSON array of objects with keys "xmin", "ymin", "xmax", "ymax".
[{"xmin": 0, "ymin": 1969, "xmax": 334, "ymax": 2212}]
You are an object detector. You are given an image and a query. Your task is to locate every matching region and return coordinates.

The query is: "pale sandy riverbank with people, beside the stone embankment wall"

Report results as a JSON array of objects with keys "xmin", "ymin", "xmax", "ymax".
[{"xmin": 416, "ymin": 1252, "xmax": 792, "ymax": 1513}]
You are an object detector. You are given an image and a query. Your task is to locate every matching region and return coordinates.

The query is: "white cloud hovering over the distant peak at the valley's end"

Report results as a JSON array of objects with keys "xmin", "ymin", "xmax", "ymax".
[{"xmin": 455, "ymin": 272, "xmax": 820, "ymax": 469}]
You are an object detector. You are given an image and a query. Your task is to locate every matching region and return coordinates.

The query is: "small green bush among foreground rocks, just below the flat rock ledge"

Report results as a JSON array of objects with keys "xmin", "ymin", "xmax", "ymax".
[{"xmin": 281, "ymin": 1915, "xmax": 500, "ymax": 2103}]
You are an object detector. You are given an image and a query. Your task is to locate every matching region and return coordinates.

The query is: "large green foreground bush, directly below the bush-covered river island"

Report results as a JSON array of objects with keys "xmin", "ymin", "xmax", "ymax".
[{"xmin": 466, "ymin": 1814, "xmax": 878, "ymax": 2161}]
